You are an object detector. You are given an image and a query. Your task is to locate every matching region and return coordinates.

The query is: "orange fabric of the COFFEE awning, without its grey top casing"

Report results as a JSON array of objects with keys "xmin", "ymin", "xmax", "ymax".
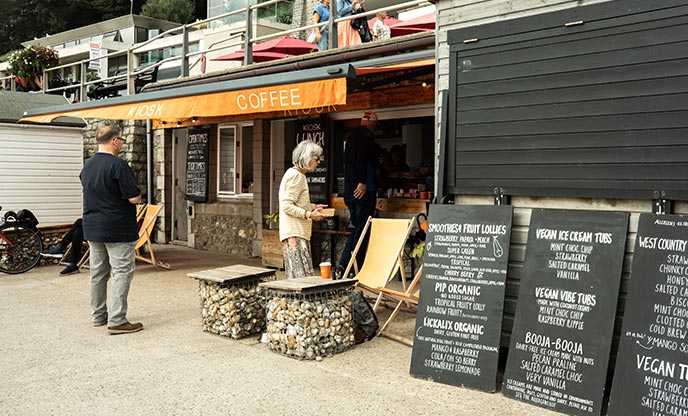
[{"xmin": 19, "ymin": 78, "xmax": 346, "ymax": 123}]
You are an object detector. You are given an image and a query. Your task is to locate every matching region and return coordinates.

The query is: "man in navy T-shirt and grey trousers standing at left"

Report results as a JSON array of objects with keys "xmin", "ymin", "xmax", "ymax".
[{"xmin": 79, "ymin": 125, "xmax": 143, "ymax": 334}]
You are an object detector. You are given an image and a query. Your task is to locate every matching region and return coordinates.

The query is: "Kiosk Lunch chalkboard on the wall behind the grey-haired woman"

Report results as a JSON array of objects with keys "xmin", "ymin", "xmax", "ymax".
[{"xmin": 292, "ymin": 118, "xmax": 332, "ymax": 204}]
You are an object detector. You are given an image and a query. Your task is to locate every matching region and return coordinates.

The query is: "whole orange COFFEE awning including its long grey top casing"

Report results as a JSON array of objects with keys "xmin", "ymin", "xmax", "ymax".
[{"xmin": 19, "ymin": 64, "xmax": 355, "ymax": 127}]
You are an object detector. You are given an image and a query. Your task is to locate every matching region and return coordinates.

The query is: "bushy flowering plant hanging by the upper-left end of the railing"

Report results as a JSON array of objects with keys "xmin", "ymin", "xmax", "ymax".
[{"xmin": 8, "ymin": 45, "xmax": 60, "ymax": 91}]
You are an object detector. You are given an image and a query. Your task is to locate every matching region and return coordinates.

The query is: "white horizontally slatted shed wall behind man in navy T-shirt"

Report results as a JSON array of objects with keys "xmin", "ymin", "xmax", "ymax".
[{"xmin": 0, "ymin": 124, "xmax": 84, "ymax": 225}]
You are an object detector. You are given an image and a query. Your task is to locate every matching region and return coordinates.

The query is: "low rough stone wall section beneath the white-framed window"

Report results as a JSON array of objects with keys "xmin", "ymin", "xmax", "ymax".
[{"xmin": 189, "ymin": 200, "xmax": 258, "ymax": 257}]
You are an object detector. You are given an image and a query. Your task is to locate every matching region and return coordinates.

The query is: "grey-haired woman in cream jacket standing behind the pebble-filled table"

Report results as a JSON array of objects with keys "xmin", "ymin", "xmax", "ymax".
[{"xmin": 279, "ymin": 140, "xmax": 327, "ymax": 279}]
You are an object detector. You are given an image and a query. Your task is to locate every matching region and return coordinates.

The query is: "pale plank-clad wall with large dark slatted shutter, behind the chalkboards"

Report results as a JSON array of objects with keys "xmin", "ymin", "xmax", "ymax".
[{"xmin": 436, "ymin": 0, "xmax": 688, "ymax": 355}]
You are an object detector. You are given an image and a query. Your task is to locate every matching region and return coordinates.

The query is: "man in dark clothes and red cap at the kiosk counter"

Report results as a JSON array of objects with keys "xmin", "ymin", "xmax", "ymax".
[{"xmin": 335, "ymin": 111, "xmax": 380, "ymax": 278}]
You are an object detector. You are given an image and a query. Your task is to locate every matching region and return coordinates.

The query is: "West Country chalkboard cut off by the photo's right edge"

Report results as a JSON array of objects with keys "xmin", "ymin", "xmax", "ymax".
[{"xmin": 607, "ymin": 214, "xmax": 688, "ymax": 416}]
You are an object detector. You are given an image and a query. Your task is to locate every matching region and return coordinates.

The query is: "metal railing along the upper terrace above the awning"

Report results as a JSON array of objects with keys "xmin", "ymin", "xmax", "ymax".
[{"xmin": 5, "ymin": 0, "xmax": 432, "ymax": 101}]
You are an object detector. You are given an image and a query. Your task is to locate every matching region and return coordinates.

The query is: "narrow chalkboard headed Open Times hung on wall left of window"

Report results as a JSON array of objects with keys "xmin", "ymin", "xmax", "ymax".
[{"xmin": 185, "ymin": 129, "xmax": 210, "ymax": 202}]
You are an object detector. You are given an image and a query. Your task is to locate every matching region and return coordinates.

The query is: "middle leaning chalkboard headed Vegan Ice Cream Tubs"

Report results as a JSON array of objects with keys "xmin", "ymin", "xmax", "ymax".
[{"xmin": 502, "ymin": 210, "xmax": 628, "ymax": 415}]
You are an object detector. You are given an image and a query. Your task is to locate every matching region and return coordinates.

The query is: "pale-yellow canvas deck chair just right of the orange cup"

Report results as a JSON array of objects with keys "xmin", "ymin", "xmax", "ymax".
[{"xmin": 344, "ymin": 217, "xmax": 413, "ymax": 311}]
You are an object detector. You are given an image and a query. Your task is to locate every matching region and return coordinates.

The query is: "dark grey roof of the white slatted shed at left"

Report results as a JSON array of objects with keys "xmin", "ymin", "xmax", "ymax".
[{"xmin": 0, "ymin": 90, "xmax": 86, "ymax": 127}]
